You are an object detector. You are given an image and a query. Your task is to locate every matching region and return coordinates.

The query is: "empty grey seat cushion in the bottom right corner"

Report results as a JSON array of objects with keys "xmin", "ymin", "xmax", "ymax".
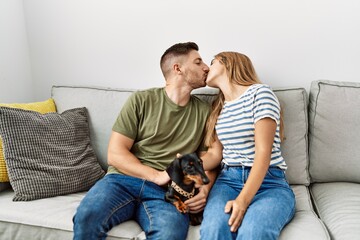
[{"xmin": 311, "ymin": 182, "xmax": 360, "ymax": 240}]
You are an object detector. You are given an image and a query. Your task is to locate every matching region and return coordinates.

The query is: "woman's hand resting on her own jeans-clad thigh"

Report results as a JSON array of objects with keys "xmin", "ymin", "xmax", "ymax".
[{"xmin": 225, "ymin": 197, "xmax": 248, "ymax": 232}]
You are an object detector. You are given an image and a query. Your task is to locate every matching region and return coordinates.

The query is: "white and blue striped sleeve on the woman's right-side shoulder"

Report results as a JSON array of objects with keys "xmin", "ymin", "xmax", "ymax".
[{"xmin": 253, "ymin": 86, "xmax": 280, "ymax": 123}]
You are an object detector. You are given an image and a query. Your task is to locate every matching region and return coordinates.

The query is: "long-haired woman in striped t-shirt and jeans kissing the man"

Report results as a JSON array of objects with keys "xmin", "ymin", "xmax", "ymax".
[{"xmin": 200, "ymin": 52, "xmax": 295, "ymax": 240}]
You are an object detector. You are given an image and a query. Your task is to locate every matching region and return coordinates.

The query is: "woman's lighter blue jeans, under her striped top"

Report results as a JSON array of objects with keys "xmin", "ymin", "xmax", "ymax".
[{"xmin": 200, "ymin": 165, "xmax": 295, "ymax": 240}]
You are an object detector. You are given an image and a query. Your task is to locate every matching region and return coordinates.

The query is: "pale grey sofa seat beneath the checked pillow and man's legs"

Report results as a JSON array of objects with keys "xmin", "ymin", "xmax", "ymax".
[{"xmin": 0, "ymin": 190, "xmax": 142, "ymax": 240}]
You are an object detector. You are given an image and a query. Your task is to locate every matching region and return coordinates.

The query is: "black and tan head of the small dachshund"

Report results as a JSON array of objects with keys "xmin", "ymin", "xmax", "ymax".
[{"xmin": 167, "ymin": 153, "xmax": 210, "ymax": 185}]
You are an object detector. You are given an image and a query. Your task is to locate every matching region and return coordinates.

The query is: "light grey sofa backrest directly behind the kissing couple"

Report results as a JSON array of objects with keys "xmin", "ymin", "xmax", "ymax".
[{"xmin": 52, "ymin": 86, "xmax": 310, "ymax": 185}]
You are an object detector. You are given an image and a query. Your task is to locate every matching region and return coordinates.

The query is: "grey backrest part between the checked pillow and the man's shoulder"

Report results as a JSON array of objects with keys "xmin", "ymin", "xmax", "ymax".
[{"xmin": 51, "ymin": 86, "xmax": 135, "ymax": 170}]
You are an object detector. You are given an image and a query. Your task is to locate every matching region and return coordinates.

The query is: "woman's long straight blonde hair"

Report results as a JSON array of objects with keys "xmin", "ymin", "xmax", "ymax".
[{"xmin": 205, "ymin": 52, "xmax": 283, "ymax": 146}]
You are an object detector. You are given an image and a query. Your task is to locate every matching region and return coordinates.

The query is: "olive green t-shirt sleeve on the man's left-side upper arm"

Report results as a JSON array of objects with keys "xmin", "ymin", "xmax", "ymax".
[{"xmin": 112, "ymin": 93, "xmax": 140, "ymax": 140}]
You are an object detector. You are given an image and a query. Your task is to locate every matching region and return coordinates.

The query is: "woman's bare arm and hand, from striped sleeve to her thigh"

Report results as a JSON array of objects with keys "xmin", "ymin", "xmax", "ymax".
[{"xmin": 225, "ymin": 118, "xmax": 276, "ymax": 232}]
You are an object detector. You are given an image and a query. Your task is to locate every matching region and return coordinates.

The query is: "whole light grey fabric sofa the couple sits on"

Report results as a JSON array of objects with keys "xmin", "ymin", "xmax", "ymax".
[{"xmin": 0, "ymin": 80, "xmax": 360, "ymax": 240}]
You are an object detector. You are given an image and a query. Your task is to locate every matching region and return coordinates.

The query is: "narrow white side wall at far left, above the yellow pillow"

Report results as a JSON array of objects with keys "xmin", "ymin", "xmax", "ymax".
[{"xmin": 0, "ymin": 0, "xmax": 34, "ymax": 103}]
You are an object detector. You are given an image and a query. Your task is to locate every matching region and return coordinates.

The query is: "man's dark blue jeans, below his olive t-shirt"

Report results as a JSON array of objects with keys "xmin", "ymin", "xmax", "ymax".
[{"xmin": 73, "ymin": 174, "xmax": 189, "ymax": 240}]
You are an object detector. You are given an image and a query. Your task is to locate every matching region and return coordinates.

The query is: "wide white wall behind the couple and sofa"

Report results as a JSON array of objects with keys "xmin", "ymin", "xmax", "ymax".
[{"xmin": 9, "ymin": 0, "xmax": 360, "ymax": 100}]
